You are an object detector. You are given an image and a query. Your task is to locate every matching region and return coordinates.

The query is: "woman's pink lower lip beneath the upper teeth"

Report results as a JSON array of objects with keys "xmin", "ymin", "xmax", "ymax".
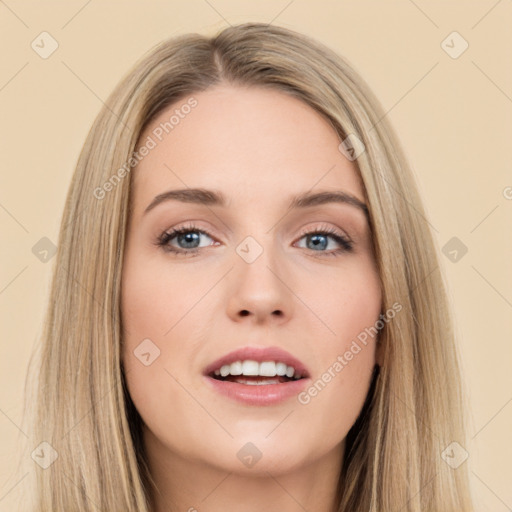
[{"xmin": 204, "ymin": 375, "xmax": 309, "ymax": 405}]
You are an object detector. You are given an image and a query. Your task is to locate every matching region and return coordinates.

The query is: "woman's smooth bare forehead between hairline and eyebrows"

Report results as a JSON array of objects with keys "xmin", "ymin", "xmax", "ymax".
[{"xmin": 133, "ymin": 84, "xmax": 364, "ymax": 214}]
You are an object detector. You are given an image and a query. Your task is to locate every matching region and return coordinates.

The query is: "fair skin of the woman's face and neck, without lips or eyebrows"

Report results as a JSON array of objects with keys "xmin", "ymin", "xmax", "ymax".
[{"xmin": 122, "ymin": 84, "xmax": 382, "ymax": 512}]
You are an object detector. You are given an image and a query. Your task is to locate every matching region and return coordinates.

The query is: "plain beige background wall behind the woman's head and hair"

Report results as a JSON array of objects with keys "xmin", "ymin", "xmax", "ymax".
[{"xmin": 0, "ymin": 0, "xmax": 512, "ymax": 512}]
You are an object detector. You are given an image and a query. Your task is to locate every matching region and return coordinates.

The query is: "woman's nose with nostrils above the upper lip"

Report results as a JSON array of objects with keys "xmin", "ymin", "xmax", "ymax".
[{"xmin": 227, "ymin": 247, "xmax": 295, "ymax": 324}]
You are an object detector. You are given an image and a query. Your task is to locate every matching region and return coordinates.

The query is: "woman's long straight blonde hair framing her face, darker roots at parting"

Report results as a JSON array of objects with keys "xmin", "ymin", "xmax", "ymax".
[{"xmin": 25, "ymin": 23, "xmax": 473, "ymax": 512}]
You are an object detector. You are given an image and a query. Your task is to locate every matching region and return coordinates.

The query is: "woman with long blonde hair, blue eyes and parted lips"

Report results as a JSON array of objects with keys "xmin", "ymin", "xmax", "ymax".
[{"xmin": 21, "ymin": 23, "xmax": 472, "ymax": 512}]
